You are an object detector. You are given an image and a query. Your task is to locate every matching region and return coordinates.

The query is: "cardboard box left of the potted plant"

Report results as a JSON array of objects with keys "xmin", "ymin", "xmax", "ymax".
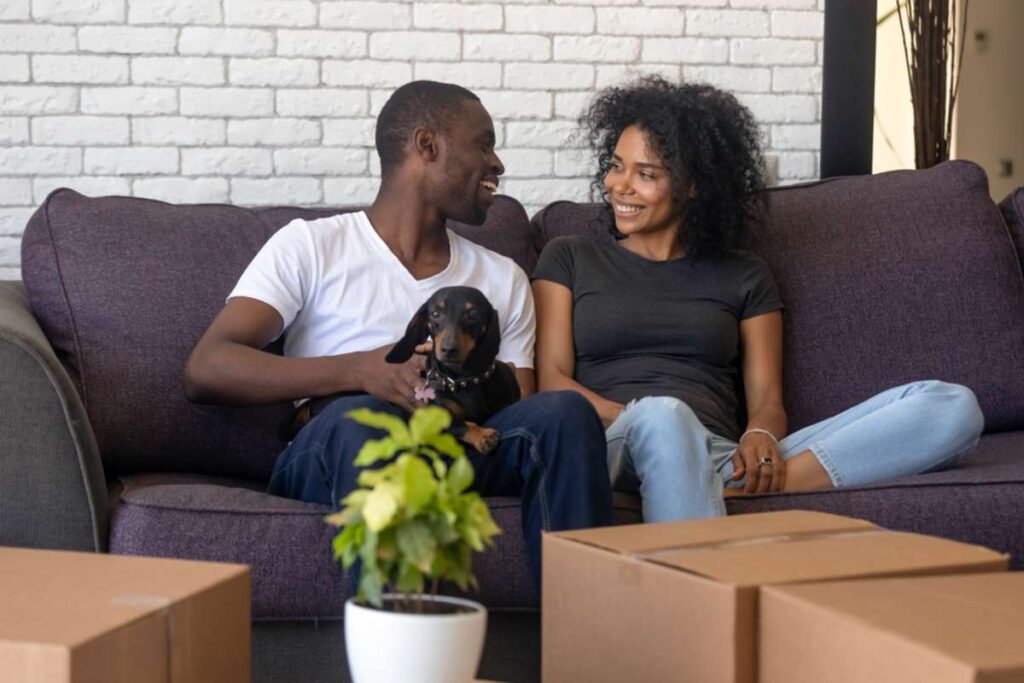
[{"xmin": 0, "ymin": 548, "xmax": 249, "ymax": 683}]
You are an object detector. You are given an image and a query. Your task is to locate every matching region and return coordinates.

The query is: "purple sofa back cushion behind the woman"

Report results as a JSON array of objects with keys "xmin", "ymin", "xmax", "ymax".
[{"xmin": 534, "ymin": 162, "xmax": 1024, "ymax": 431}]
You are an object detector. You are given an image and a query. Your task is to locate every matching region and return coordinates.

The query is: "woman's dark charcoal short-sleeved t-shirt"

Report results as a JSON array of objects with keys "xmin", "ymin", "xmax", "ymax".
[{"xmin": 532, "ymin": 233, "xmax": 782, "ymax": 439}]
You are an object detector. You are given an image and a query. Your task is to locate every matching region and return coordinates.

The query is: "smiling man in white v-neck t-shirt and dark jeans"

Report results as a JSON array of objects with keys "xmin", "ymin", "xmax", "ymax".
[{"xmin": 185, "ymin": 81, "xmax": 611, "ymax": 586}]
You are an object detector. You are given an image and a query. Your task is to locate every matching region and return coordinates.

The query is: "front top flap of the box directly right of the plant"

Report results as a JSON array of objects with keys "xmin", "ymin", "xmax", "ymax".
[{"xmin": 644, "ymin": 527, "xmax": 1008, "ymax": 586}]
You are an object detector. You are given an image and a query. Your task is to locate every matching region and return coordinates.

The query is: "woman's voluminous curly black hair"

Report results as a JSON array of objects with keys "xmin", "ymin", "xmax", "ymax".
[{"xmin": 580, "ymin": 76, "xmax": 765, "ymax": 257}]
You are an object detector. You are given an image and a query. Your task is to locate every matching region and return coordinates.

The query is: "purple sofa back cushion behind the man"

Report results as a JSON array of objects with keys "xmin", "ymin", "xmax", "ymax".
[{"xmin": 22, "ymin": 189, "xmax": 536, "ymax": 479}]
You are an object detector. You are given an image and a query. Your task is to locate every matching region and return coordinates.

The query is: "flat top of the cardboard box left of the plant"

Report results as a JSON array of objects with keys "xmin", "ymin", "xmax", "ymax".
[{"xmin": 0, "ymin": 548, "xmax": 249, "ymax": 647}]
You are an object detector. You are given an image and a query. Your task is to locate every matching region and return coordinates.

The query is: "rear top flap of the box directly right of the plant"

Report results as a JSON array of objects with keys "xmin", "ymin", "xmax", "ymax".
[{"xmin": 555, "ymin": 510, "xmax": 879, "ymax": 555}]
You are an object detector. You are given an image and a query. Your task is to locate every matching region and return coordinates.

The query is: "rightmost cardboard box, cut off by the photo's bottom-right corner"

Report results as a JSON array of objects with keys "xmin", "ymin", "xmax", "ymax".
[{"xmin": 761, "ymin": 572, "xmax": 1024, "ymax": 683}]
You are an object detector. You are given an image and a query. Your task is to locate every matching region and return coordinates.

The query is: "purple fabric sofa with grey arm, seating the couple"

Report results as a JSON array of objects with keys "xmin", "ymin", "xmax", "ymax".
[{"xmin": 0, "ymin": 162, "xmax": 1024, "ymax": 681}]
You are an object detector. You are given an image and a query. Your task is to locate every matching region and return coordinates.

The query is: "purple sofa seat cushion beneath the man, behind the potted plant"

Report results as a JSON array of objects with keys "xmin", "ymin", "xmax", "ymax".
[{"xmin": 110, "ymin": 473, "xmax": 552, "ymax": 620}]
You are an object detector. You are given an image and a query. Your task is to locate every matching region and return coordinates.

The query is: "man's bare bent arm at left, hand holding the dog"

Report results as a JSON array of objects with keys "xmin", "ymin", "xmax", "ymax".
[{"xmin": 184, "ymin": 297, "xmax": 424, "ymax": 410}]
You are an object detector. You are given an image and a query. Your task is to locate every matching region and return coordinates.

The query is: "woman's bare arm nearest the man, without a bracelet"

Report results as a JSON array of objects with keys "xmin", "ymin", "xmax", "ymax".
[{"xmin": 534, "ymin": 280, "xmax": 625, "ymax": 426}]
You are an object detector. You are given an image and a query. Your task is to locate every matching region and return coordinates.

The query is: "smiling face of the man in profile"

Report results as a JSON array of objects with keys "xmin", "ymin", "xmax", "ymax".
[{"xmin": 432, "ymin": 99, "xmax": 505, "ymax": 225}]
